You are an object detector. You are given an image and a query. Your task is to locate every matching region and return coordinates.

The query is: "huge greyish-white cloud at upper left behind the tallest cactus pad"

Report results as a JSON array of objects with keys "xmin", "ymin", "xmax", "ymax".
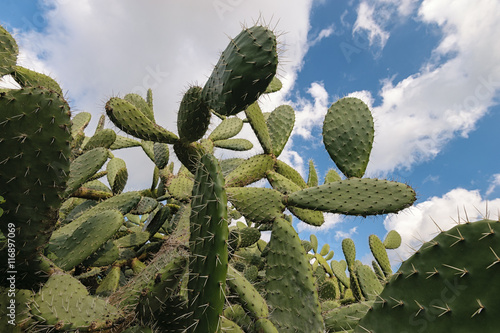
[{"xmin": 16, "ymin": 0, "xmax": 314, "ymax": 188}]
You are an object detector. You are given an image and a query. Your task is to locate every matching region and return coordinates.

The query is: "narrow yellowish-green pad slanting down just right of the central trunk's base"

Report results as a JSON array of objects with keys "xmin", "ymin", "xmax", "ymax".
[{"xmin": 227, "ymin": 265, "xmax": 269, "ymax": 318}]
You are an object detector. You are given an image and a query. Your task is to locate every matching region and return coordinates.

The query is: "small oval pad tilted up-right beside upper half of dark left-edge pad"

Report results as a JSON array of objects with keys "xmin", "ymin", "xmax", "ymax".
[{"xmin": 65, "ymin": 147, "xmax": 109, "ymax": 195}]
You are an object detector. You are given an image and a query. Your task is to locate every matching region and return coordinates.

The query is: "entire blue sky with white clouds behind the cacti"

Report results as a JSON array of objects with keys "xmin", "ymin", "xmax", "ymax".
[{"xmin": 0, "ymin": 0, "xmax": 500, "ymax": 264}]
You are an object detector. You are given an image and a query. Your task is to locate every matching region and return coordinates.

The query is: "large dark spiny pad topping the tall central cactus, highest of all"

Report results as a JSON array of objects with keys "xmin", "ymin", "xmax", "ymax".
[{"xmin": 203, "ymin": 26, "xmax": 278, "ymax": 116}]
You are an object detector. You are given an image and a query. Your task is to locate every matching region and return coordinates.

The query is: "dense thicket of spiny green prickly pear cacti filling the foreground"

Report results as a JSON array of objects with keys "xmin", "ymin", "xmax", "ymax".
[{"xmin": 0, "ymin": 25, "xmax": 500, "ymax": 333}]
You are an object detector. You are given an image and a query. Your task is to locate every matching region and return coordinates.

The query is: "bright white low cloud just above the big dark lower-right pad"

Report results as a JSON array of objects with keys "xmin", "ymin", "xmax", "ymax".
[{"xmin": 384, "ymin": 188, "xmax": 500, "ymax": 262}]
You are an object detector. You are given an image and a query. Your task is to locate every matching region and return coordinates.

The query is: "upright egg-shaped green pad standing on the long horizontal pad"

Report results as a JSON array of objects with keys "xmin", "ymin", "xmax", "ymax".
[{"xmin": 323, "ymin": 97, "xmax": 374, "ymax": 178}]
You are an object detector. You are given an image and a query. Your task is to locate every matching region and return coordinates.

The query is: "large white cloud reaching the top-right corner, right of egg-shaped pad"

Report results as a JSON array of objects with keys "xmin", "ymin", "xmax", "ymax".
[{"xmin": 368, "ymin": 0, "xmax": 500, "ymax": 173}]
